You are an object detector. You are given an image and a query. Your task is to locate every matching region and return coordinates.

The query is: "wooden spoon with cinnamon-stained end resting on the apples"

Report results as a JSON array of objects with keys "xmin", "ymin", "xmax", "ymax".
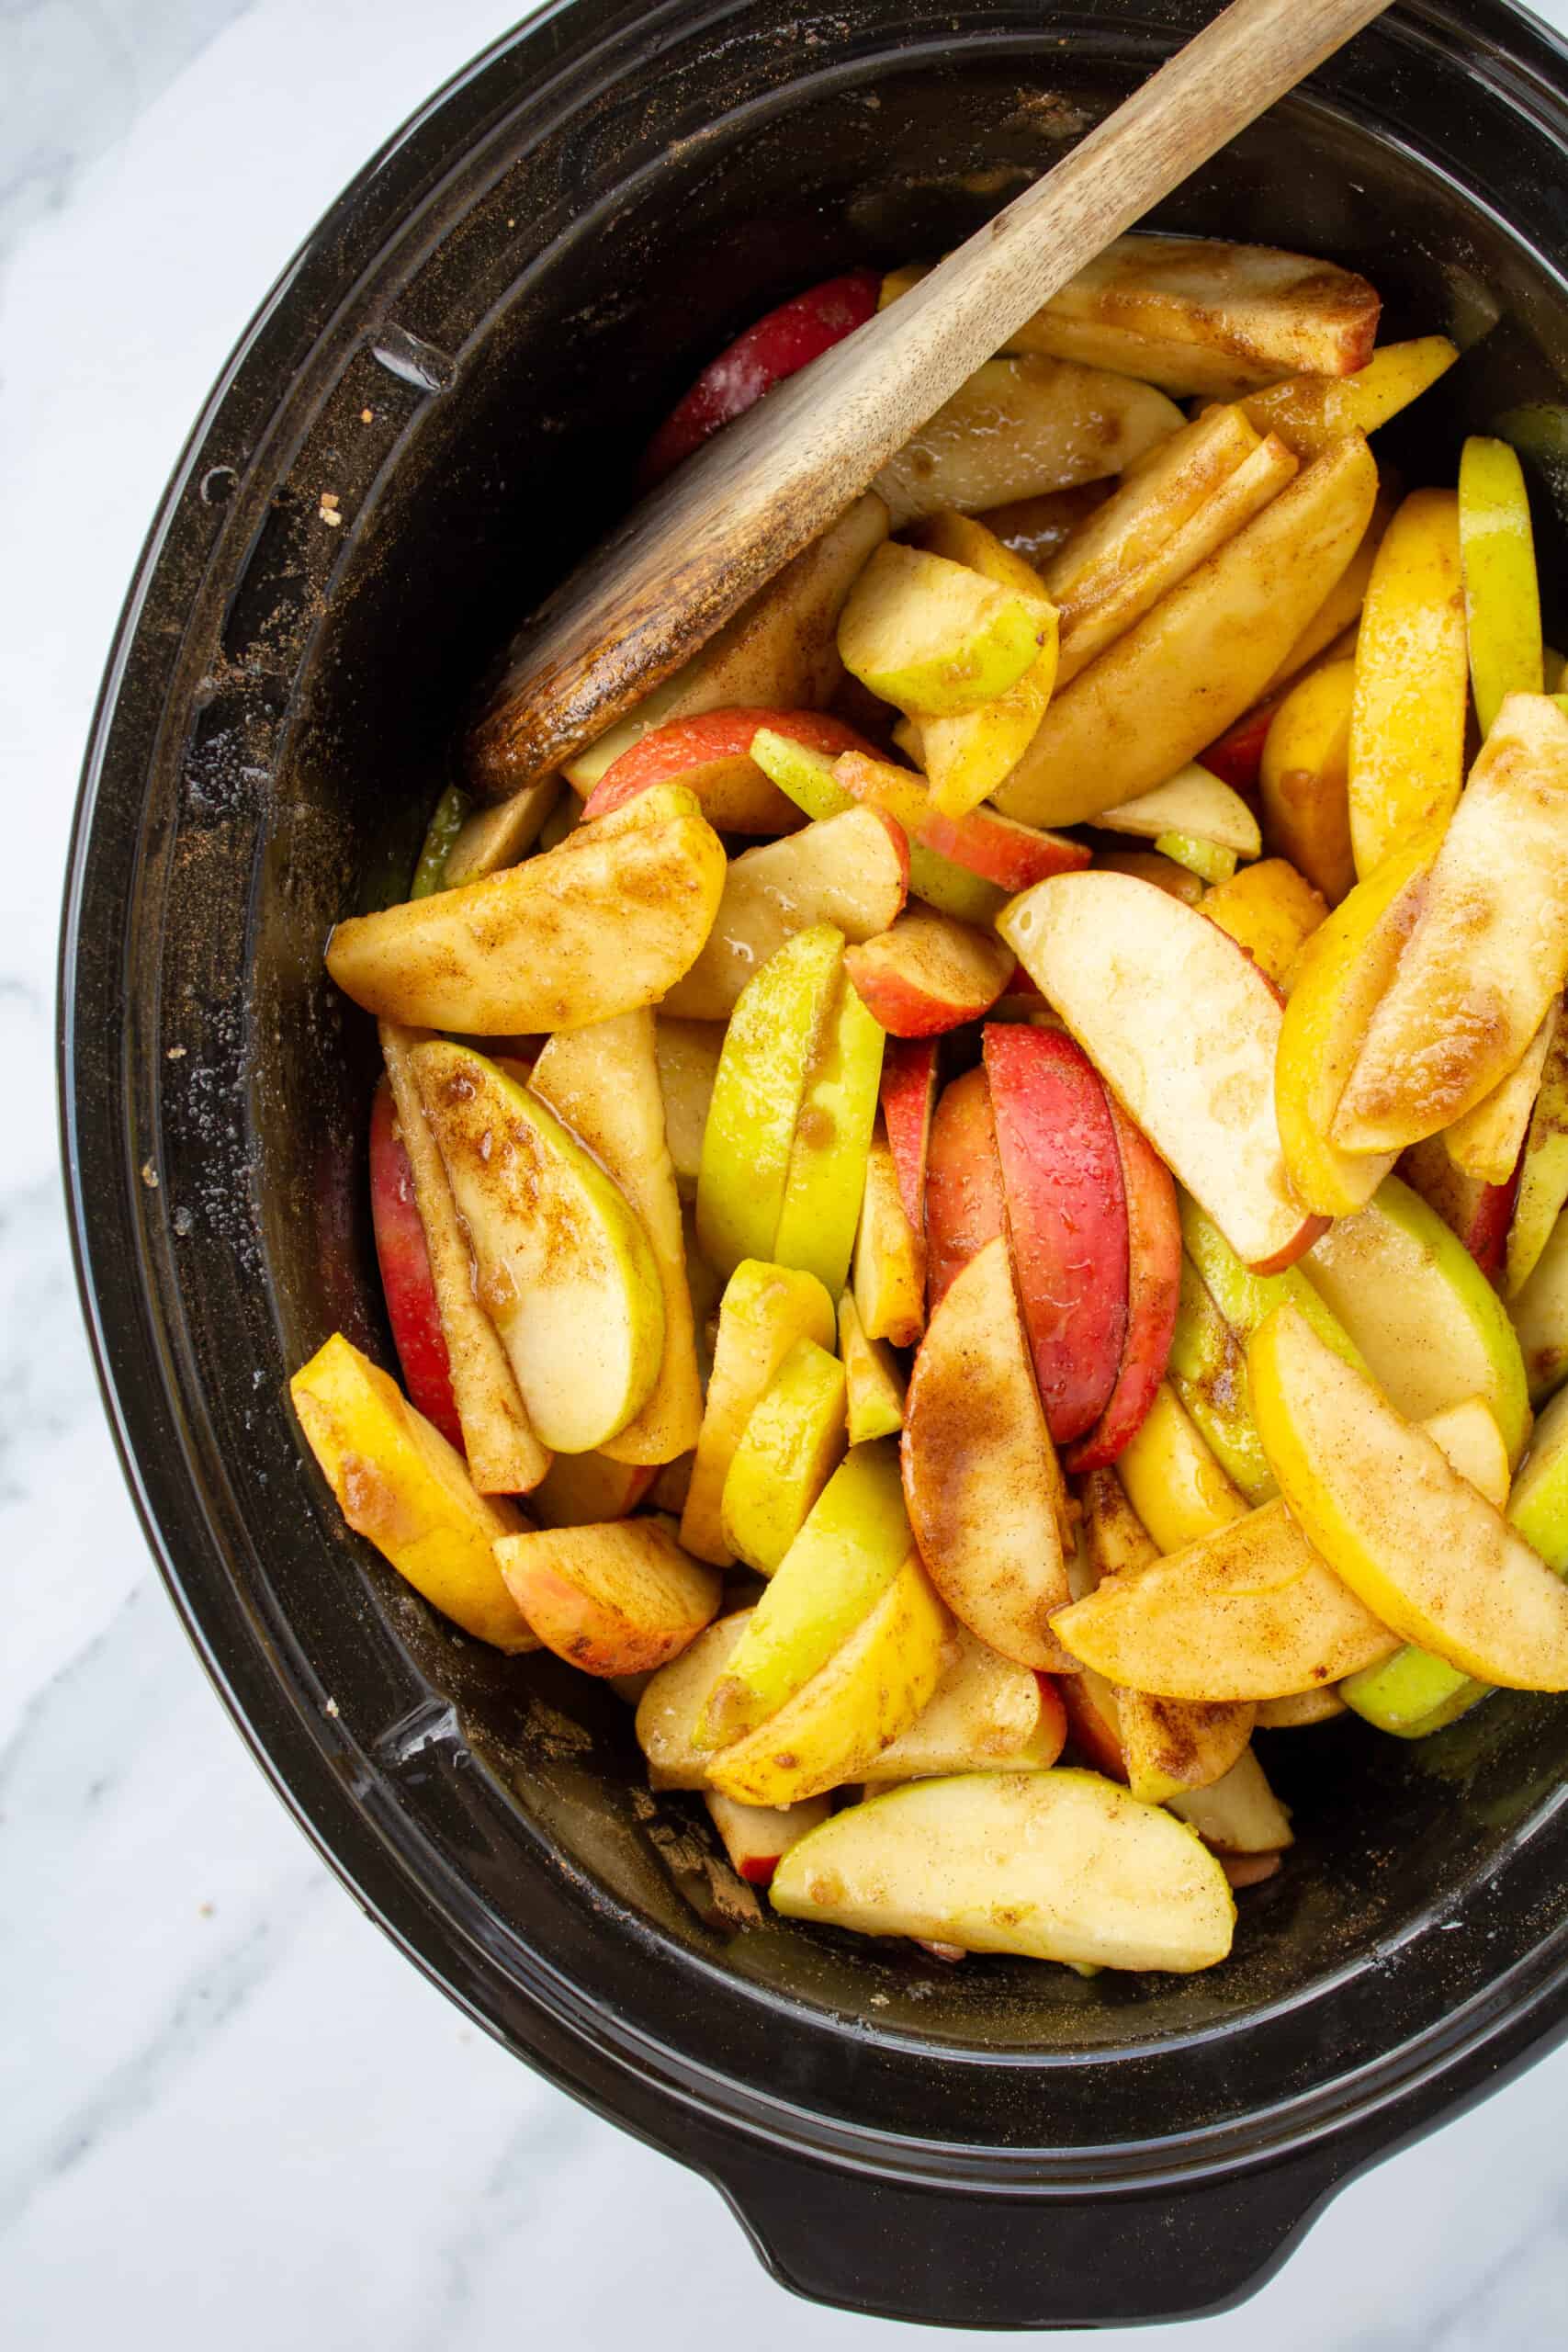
[{"xmin": 468, "ymin": 0, "xmax": 1387, "ymax": 799}]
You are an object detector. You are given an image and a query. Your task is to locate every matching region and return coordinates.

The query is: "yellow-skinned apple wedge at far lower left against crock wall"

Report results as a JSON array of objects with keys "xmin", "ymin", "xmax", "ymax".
[{"xmin": 289, "ymin": 1331, "xmax": 538, "ymax": 1651}]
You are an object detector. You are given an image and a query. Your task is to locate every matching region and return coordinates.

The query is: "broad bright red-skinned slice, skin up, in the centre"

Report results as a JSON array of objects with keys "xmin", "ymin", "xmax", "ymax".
[{"xmin": 983, "ymin": 1021, "xmax": 1126, "ymax": 1446}]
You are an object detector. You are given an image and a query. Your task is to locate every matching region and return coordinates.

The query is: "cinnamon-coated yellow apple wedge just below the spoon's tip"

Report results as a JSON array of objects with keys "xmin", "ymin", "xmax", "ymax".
[{"xmin": 327, "ymin": 783, "xmax": 724, "ymax": 1037}]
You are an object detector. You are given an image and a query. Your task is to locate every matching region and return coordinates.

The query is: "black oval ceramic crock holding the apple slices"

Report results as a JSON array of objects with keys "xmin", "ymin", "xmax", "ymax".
[{"xmin": 63, "ymin": 0, "xmax": 1568, "ymax": 2326}]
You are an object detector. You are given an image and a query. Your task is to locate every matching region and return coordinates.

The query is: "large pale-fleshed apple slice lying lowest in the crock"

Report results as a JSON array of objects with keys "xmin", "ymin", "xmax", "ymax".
[{"xmin": 771, "ymin": 1771, "xmax": 1236, "ymax": 1973}]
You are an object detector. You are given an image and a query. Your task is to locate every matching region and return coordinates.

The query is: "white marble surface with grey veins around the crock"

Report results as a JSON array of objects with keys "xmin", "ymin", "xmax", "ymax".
[{"xmin": 0, "ymin": 0, "xmax": 1568, "ymax": 2352}]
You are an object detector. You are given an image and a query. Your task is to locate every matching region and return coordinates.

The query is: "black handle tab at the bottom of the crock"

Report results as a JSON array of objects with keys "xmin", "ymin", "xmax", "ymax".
[{"xmin": 715, "ymin": 2143, "xmax": 1354, "ymax": 2328}]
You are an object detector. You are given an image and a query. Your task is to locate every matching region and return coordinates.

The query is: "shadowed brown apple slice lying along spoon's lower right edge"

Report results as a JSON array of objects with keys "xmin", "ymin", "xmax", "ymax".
[{"xmin": 557, "ymin": 492, "xmax": 888, "ymax": 799}]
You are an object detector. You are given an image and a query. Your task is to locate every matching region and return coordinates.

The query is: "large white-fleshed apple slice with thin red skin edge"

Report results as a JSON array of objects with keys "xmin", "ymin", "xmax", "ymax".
[{"xmin": 999, "ymin": 873, "xmax": 1321, "ymax": 1272}]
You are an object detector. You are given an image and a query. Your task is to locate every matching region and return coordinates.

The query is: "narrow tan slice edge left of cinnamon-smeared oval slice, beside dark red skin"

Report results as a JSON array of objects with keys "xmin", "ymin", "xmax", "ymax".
[{"xmin": 378, "ymin": 1021, "xmax": 550, "ymax": 1494}]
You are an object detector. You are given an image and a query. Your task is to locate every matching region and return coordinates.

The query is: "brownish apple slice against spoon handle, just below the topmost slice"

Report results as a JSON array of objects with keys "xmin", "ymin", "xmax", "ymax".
[{"xmin": 877, "ymin": 356, "xmax": 1182, "ymax": 532}]
